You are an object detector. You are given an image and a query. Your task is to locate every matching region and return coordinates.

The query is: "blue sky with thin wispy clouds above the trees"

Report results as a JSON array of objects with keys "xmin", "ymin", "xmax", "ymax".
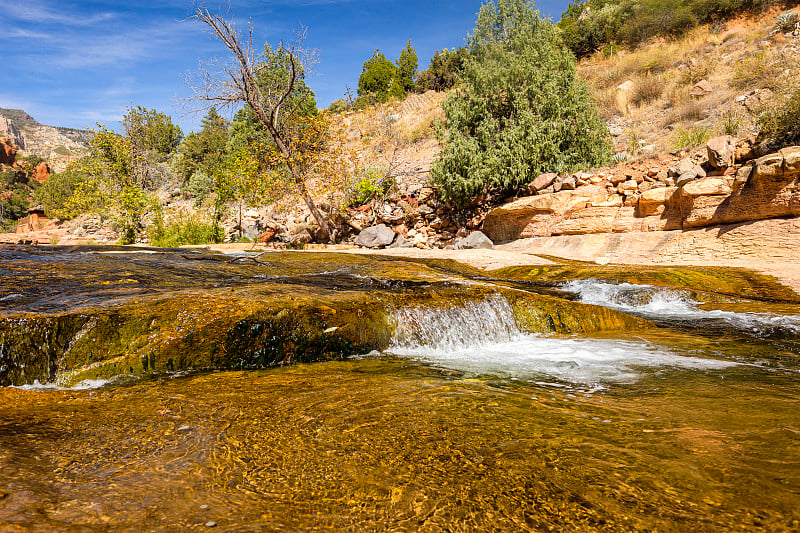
[{"xmin": 0, "ymin": 0, "xmax": 568, "ymax": 132}]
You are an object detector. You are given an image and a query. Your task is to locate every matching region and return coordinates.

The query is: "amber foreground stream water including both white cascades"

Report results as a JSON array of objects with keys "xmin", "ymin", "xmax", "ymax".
[{"xmin": 0, "ymin": 250, "xmax": 800, "ymax": 531}]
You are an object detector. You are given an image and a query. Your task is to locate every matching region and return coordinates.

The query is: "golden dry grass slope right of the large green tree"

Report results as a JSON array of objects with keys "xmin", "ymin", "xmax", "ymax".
[{"xmin": 579, "ymin": 11, "xmax": 800, "ymax": 158}]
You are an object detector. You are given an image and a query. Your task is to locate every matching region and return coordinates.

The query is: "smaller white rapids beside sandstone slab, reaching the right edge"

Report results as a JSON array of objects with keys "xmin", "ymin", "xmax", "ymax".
[{"xmin": 562, "ymin": 279, "xmax": 800, "ymax": 336}]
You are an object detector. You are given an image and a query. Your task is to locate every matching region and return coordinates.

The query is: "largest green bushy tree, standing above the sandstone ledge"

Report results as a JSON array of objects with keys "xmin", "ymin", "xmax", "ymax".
[{"xmin": 431, "ymin": 0, "xmax": 611, "ymax": 207}]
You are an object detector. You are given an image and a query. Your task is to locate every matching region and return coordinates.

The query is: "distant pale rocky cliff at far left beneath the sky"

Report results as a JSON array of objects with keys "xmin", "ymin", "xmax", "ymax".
[{"xmin": 0, "ymin": 108, "xmax": 90, "ymax": 172}]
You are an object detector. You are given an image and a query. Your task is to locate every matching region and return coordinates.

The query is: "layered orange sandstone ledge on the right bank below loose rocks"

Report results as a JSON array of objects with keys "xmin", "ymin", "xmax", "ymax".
[{"xmin": 483, "ymin": 146, "xmax": 800, "ymax": 242}]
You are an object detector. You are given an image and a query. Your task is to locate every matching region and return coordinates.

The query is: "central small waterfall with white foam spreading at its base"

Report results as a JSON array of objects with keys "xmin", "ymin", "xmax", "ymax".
[{"xmin": 387, "ymin": 296, "xmax": 735, "ymax": 385}]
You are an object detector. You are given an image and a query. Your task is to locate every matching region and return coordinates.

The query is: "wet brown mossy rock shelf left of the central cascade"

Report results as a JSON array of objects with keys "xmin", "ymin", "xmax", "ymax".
[{"xmin": 0, "ymin": 246, "xmax": 656, "ymax": 385}]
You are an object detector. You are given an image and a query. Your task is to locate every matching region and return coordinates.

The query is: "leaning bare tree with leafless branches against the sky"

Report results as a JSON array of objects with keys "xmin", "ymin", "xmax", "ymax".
[{"xmin": 190, "ymin": 7, "xmax": 335, "ymax": 241}]
